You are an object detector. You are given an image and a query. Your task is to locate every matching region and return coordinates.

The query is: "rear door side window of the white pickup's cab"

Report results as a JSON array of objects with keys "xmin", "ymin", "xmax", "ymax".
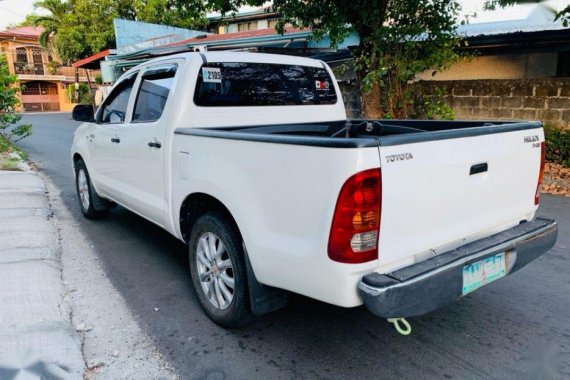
[{"xmin": 132, "ymin": 65, "xmax": 177, "ymax": 123}]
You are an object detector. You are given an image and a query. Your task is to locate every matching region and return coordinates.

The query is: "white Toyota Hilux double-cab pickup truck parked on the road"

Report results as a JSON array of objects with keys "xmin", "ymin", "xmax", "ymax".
[{"xmin": 71, "ymin": 52, "xmax": 557, "ymax": 326}]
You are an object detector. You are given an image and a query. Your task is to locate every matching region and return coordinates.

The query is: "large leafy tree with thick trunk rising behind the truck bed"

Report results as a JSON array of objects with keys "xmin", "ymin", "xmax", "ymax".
[{"xmin": 174, "ymin": 0, "xmax": 460, "ymax": 118}]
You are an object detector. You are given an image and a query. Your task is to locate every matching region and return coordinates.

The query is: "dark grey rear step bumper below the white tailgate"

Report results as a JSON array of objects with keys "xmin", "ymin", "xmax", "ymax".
[{"xmin": 358, "ymin": 218, "xmax": 558, "ymax": 318}]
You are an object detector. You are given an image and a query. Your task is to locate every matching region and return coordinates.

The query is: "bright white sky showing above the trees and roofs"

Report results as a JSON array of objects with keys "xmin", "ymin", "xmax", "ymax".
[{"xmin": 0, "ymin": 0, "xmax": 568, "ymax": 30}]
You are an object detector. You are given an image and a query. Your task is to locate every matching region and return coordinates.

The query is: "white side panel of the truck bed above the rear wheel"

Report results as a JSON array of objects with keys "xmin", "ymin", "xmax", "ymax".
[{"xmin": 172, "ymin": 135, "xmax": 379, "ymax": 307}]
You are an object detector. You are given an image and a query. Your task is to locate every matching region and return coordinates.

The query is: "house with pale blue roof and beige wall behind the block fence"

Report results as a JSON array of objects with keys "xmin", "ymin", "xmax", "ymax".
[{"xmin": 419, "ymin": 4, "xmax": 570, "ymax": 81}]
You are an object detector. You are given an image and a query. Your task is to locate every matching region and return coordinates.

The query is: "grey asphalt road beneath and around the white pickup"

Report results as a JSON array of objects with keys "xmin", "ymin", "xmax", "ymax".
[{"xmin": 15, "ymin": 114, "xmax": 570, "ymax": 379}]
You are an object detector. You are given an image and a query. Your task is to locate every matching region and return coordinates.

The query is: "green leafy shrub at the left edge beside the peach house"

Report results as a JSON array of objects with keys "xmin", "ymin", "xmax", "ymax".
[{"xmin": 0, "ymin": 55, "xmax": 32, "ymax": 152}]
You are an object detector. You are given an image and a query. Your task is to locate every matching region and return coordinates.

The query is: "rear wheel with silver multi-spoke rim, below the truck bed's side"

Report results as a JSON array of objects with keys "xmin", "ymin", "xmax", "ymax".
[{"xmin": 189, "ymin": 212, "xmax": 253, "ymax": 328}]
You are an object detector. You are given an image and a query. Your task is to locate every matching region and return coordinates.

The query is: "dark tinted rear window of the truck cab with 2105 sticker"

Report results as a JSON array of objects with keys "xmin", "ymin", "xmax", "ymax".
[{"xmin": 194, "ymin": 63, "xmax": 337, "ymax": 107}]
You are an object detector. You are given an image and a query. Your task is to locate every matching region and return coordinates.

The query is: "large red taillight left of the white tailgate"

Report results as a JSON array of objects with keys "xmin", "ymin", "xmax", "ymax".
[{"xmin": 328, "ymin": 169, "xmax": 382, "ymax": 264}]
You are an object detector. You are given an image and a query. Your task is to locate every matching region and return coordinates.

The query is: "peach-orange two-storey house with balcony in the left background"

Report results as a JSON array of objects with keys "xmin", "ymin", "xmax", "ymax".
[{"xmin": 0, "ymin": 26, "xmax": 94, "ymax": 112}]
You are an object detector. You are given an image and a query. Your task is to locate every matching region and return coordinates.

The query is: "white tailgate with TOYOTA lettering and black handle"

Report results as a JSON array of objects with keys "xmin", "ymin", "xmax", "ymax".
[{"xmin": 377, "ymin": 127, "xmax": 544, "ymax": 273}]
